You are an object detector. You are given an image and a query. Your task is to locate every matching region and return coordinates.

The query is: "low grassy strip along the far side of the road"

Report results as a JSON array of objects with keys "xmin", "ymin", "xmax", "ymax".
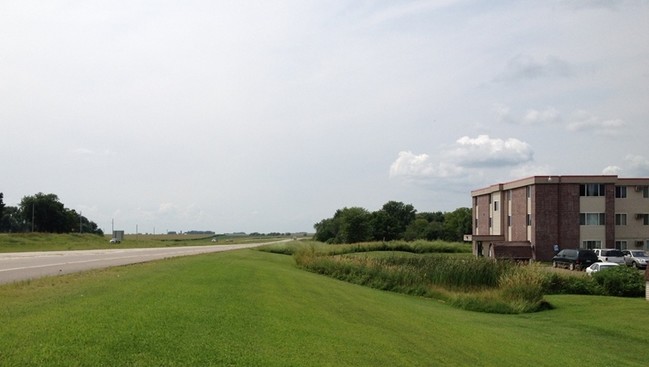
[{"xmin": 0, "ymin": 233, "xmax": 287, "ymax": 252}]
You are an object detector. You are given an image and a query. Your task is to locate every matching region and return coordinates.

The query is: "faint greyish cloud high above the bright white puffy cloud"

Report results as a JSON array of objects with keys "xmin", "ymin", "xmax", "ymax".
[{"xmin": 496, "ymin": 55, "xmax": 575, "ymax": 82}]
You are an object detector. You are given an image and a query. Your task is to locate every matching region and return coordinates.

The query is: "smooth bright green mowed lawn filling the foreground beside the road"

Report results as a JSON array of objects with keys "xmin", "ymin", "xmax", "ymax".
[{"xmin": 0, "ymin": 250, "xmax": 649, "ymax": 366}]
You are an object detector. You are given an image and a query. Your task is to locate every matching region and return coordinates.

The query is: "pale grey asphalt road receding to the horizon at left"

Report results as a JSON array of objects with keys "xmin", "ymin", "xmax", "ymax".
[{"xmin": 0, "ymin": 241, "xmax": 285, "ymax": 283}]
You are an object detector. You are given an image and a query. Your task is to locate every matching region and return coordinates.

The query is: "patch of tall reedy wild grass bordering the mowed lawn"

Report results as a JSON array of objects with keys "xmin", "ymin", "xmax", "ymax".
[{"xmin": 294, "ymin": 246, "xmax": 550, "ymax": 313}]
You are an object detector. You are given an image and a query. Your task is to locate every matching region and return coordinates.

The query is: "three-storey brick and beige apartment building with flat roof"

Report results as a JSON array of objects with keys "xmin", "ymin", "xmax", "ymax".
[{"xmin": 471, "ymin": 175, "xmax": 649, "ymax": 261}]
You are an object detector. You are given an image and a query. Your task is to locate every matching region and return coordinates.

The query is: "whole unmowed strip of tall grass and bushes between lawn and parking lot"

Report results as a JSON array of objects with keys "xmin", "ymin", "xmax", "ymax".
[{"xmin": 260, "ymin": 241, "xmax": 645, "ymax": 314}]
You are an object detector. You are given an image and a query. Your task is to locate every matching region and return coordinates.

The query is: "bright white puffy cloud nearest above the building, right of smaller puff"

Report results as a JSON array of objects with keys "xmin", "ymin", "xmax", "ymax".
[{"xmin": 450, "ymin": 135, "xmax": 534, "ymax": 167}]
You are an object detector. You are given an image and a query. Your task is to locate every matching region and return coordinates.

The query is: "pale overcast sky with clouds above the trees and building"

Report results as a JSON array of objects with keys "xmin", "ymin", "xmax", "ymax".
[{"xmin": 0, "ymin": 0, "xmax": 649, "ymax": 233}]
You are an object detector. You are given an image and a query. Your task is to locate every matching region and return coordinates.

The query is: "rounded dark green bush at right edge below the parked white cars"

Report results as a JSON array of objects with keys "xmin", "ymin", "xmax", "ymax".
[{"xmin": 593, "ymin": 266, "xmax": 645, "ymax": 297}]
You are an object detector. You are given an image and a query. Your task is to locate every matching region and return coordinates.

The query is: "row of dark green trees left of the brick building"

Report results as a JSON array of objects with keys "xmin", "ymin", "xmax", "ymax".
[{"xmin": 313, "ymin": 201, "xmax": 472, "ymax": 243}]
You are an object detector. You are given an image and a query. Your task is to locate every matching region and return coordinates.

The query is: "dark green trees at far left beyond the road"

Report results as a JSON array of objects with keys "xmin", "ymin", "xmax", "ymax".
[{"xmin": 0, "ymin": 192, "xmax": 104, "ymax": 236}]
